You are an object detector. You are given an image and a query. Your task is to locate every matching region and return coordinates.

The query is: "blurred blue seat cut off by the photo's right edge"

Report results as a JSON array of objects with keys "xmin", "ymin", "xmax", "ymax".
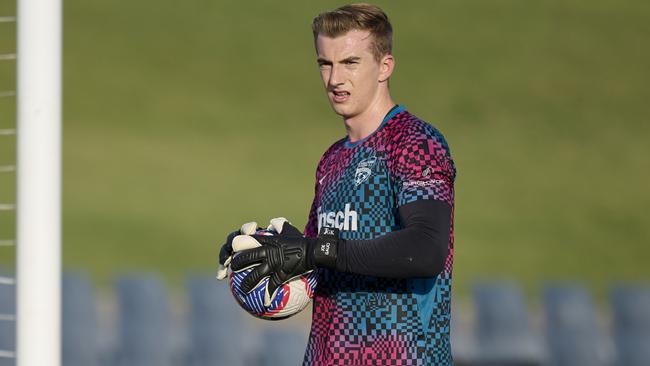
[{"xmin": 611, "ymin": 285, "xmax": 650, "ymax": 366}]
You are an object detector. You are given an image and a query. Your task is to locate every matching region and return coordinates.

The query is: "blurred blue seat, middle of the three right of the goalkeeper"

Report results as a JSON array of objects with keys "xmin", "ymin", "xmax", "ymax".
[{"xmin": 543, "ymin": 284, "xmax": 612, "ymax": 366}]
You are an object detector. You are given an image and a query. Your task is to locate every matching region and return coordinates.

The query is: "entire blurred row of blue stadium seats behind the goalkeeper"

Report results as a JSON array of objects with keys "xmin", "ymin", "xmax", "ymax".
[{"xmin": 0, "ymin": 272, "xmax": 650, "ymax": 366}]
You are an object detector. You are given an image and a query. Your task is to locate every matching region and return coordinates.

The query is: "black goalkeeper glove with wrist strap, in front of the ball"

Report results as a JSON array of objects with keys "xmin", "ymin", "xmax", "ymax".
[{"xmin": 230, "ymin": 218, "xmax": 338, "ymax": 306}]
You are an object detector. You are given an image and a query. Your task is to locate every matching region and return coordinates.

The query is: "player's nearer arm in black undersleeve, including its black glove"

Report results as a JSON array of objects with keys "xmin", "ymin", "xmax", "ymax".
[{"xmin": 231, "ymin": 200, "xmax": 451, "ymax": 298}]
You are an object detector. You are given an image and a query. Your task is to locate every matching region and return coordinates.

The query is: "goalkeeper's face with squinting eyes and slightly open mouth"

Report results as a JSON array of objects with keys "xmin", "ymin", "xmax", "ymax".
[{"xmin": 316, "ymin": 30, "xmax": 393, "ymax": 118}]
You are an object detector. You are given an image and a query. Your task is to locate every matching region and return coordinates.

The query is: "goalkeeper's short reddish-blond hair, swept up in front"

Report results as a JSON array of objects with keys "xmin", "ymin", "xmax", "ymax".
[{"xmin": 311, "ymin": 4, "xmax": 393, "ymax": 62}]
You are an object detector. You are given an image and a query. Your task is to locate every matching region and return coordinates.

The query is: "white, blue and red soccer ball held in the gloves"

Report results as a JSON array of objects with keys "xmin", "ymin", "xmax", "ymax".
[{"xmin": 229, "ymin": 230, "xmax": 317, "ymax": 320}]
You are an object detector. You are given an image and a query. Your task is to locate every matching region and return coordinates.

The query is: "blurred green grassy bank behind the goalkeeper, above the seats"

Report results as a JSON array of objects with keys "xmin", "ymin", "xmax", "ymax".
[{"xmin": 0, "ymin": 0, "xmax": 650, "ymax": 364}]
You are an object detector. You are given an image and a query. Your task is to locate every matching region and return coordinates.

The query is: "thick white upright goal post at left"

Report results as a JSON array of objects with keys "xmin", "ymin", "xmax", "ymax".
[{"xmin": 16, "ymin": 0, "xmax": 62, "ymax": 366}]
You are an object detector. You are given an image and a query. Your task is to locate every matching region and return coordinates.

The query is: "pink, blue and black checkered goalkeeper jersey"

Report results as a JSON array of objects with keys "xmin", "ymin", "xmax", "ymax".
[{"xmin": 304, "ymin": 106, "xmax": 456, "ymax": 366}]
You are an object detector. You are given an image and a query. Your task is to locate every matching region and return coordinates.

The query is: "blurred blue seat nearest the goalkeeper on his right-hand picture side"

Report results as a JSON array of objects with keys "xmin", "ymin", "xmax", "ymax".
[{"xmin": 474, "ymin": 282, "xmax": 543, "ymax": 366}]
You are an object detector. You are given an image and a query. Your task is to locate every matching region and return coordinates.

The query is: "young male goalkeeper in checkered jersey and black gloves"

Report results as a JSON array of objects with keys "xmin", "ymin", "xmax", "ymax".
[{"xmin": 221, "ymin": 4, "xmax": 456, "ymax": 366}]
